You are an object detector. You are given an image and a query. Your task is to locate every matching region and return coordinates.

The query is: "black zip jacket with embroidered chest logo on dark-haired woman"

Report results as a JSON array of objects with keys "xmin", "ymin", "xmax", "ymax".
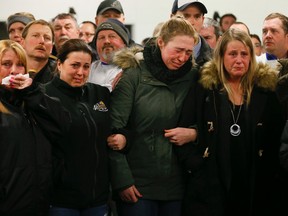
[{"xmin": 45, "ymin": 77, "xmax": 110, "ymax": 208}]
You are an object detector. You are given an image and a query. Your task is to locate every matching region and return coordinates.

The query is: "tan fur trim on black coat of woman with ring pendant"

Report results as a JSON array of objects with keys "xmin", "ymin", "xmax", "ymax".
[{"xmin": 199, "ymin": 60, "xmax": 277, "ymax": 91}]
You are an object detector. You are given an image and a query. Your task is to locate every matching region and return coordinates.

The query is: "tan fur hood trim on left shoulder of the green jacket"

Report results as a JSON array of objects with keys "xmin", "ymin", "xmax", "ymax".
[{"xmin": 113, "ymin": 45, "xmax": 144, "ymax": 70}]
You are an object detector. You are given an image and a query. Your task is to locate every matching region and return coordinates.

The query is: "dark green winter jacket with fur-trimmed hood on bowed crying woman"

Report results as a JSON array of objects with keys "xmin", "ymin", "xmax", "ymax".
[{"xmin": 109, "ymin": 44, "xmax": 199, "ymax": 201}]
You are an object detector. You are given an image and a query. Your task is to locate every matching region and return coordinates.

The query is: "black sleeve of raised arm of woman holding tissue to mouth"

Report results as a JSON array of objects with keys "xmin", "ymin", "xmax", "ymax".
[{"xmin": 18, "ymin": 84, "xmax": 71, "ymax": 142}]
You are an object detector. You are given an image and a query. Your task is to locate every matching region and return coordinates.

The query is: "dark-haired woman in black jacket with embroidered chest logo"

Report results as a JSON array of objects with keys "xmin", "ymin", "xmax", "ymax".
[{"xmin": 45, "ymin": 39, "xmax": 110, "ymax": 216}]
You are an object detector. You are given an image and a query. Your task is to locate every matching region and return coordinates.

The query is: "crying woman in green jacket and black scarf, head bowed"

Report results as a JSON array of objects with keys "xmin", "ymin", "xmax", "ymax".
[{"xmin": 108, "ymin": 17, "xmax": 198, "ymax": 216}]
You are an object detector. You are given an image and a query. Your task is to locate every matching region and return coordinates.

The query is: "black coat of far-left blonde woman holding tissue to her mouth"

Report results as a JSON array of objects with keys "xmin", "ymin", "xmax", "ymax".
[{"xmin": 0, "ymin": 86, "xmax": 70, "ymax": 216}]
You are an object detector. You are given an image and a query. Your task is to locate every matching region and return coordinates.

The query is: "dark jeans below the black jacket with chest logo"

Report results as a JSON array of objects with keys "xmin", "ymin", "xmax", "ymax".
[{"xmin": 49, "ymin": 205, "xmax": 108, "ymax": 216}]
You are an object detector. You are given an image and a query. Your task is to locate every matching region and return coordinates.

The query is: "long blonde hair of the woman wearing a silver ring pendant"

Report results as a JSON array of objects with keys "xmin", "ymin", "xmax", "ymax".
[{"xmin": 214, "ymin": 29, "xmax": 258, "ymax": 105}]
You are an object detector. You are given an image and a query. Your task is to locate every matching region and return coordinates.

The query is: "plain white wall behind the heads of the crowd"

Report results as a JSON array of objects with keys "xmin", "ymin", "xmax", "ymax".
[{"xmin": 0, "ymin": 0, "xmax": 288, "ymax": 43}]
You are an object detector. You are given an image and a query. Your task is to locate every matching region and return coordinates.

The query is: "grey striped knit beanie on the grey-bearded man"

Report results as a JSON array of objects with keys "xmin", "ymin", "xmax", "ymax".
[{"xmin": 96, "ymin": 19, "xmax": 130, "ymax": 46}]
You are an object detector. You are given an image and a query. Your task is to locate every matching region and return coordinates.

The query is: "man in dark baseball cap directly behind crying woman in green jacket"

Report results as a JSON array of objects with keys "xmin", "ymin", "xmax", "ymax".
[{"xmin": 171, "ymin": 0, "xmax": 213, "ymax": 66}]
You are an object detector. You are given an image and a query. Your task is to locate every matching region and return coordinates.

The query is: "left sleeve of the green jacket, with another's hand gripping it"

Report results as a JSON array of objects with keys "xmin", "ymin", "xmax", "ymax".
[{"xmin": 109, "ymin": 70, "xmax": 138, "ymax": 190}]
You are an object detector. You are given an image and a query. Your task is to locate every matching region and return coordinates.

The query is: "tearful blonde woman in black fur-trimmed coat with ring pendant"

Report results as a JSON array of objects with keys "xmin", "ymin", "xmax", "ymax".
[{"xmin": 182, "ymin": 29, "xmax": 284, "ymax": 216}]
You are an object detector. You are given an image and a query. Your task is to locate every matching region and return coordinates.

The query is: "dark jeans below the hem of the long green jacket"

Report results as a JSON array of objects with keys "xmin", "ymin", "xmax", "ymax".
[{"xmin": 116, "ymin": 199, "xmax": 181, "ymax": 216}]
